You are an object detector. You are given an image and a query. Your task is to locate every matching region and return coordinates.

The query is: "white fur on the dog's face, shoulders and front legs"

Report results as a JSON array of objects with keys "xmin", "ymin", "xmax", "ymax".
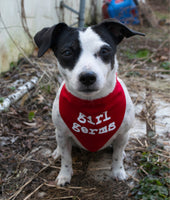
[{"xmin": 52, "ymin": 28, "xmax": 134, "ymax": 185}]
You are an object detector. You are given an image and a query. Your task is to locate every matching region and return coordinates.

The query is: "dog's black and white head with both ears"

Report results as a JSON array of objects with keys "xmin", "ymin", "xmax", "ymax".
[{"xmin": 34, "ymin": 20, "xmax": 143, "ymax": 97}]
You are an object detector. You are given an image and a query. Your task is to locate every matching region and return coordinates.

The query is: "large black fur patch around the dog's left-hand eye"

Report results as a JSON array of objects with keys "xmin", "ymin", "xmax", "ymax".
[{"xmin": 52, "ymin": 27, "xmax": 81, "ymax": 70}]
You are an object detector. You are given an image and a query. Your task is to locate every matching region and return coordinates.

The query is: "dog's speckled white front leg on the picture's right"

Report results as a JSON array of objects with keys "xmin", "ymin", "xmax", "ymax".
[{"xmin": 112, "ymin": 133, "xmax": 128, "ymax": 180}]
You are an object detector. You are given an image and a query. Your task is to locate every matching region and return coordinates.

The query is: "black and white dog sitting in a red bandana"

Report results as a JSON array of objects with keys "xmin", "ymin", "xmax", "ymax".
[{"xmin": 34, "ymin": 19, "xmax": 144, "ymax": 186}]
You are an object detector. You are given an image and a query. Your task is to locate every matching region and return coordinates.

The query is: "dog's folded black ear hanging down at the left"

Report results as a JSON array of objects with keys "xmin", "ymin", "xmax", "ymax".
[{"xmin": 34, "ymin": 23, "xmax": 68, "ymax": 57}]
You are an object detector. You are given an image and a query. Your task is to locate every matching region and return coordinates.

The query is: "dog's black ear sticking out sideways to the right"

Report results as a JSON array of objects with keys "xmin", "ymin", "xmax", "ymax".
[{"xmin": 96, "ymin": 19, "xmax": 145, "ymax": 44}]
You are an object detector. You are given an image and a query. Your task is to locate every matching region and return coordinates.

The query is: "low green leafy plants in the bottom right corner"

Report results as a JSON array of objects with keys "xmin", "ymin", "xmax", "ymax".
[{"xmin": 132, "ymin": 151, "xmax": 170, "ymax": 200}]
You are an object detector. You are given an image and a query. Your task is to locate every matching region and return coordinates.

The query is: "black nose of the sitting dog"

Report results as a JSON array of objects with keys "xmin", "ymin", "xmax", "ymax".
[{"xmin": 79, "ymin": 72, "xmax": 96, "ymax": 86}]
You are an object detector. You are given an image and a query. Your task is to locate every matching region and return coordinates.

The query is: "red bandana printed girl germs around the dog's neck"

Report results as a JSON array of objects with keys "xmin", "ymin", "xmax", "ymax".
[{"xmin": 59, "ymin": 80, "xmax": 126, "ymax": 152}]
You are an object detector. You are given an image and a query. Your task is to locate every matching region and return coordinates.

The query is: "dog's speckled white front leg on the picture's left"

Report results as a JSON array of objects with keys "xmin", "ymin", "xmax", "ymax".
[{"xmin": 53, "ymin": 130, "xmax": 73, "ymax": 186}]
